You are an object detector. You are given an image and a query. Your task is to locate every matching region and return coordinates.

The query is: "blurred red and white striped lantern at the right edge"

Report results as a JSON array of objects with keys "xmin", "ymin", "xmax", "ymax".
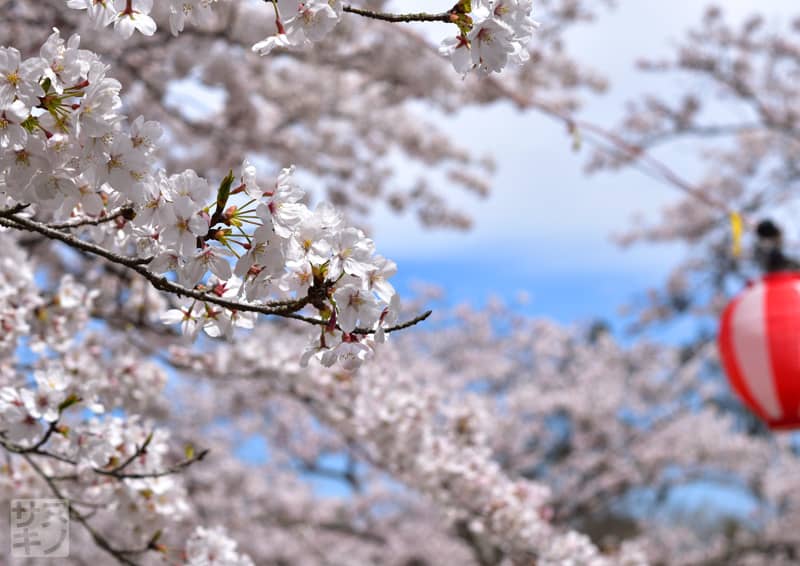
[{"xmin": 719, "ymin": 272, "xmax": 800, "ymax": 429}]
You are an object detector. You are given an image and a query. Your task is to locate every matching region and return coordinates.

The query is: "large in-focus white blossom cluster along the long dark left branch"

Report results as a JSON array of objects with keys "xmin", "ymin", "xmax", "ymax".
[{"xmin": 0, "ymin": 31, "xmax": 398, "ymax": 366}]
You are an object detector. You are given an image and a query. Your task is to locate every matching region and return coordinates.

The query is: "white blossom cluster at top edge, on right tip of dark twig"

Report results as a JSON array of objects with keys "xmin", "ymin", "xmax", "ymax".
[{"xmin": 439, "ymin": 0, "xmax": 538, "ymax": 73}]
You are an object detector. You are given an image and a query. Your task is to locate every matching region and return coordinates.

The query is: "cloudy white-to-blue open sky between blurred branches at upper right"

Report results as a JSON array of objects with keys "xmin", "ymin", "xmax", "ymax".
[{"xmin": 372, "ymin": 0, "xmax": 796, "ymax": 336}]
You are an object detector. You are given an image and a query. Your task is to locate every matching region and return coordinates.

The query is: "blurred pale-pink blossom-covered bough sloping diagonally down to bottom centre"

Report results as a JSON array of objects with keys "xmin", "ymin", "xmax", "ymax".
[{"xmin": 172, "ymin": 327, "xmax": 645, "ymax": 566}]
